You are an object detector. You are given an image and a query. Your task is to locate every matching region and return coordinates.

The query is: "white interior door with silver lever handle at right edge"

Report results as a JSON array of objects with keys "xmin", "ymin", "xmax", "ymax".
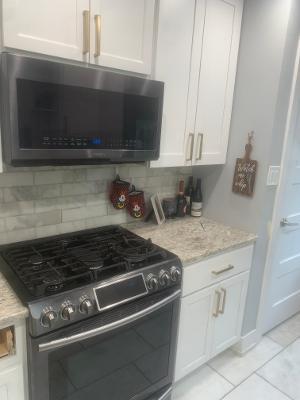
[{"xmin": 262, "ymin": 41, "xmax": 300, "ymax": 332}]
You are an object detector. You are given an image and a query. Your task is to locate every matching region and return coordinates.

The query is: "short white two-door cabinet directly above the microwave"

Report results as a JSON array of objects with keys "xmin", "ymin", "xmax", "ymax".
[{"xmin": 2, "ymin": 0, "xmax": 156, "ymax": 74}]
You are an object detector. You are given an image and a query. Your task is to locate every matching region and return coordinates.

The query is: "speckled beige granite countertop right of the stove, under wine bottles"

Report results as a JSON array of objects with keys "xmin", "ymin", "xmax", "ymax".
[{"xmin": 125, "ymin": 217, "xmax": 256, "ymax": 265}]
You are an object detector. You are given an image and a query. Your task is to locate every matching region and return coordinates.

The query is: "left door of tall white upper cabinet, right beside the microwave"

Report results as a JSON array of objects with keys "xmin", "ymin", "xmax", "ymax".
[{"xmin": 151, "ymin": 0, "xmax": 195, "ymax": 167}]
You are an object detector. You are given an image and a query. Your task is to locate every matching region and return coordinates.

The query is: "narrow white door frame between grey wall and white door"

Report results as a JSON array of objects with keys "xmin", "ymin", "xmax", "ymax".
[{"xmin": 256, "ymin": 37, "xmax": 300, "ymax": 339}]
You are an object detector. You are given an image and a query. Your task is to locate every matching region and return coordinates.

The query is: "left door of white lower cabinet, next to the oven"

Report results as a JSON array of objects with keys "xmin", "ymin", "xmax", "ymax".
[{"xmin": 175, "ymin": 288, "xmax": 214, "ymax": 381}]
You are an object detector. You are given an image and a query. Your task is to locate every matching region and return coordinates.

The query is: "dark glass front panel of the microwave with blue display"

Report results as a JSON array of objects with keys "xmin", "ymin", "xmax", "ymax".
[{"xmin": 17, "ymin": 79, "xmax": 159, "ymax": 150}]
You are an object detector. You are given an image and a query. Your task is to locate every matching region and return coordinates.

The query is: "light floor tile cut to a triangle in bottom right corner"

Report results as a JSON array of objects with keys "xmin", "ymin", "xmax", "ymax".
[{"xmin": 257, "ymin": 339, "xmax": 300, "ymax": 400}]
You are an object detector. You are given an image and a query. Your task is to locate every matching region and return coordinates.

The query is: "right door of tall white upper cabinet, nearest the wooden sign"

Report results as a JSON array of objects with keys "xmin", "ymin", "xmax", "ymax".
[{"xmin": 191, "ymin": 0, "xmax": 243, "ymax": 165}]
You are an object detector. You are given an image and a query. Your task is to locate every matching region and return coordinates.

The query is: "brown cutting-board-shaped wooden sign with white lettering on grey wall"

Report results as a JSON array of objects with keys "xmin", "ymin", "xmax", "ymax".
[{"xmin": 232, "ymin": 132, "xmax": 257, "ymax": 197}]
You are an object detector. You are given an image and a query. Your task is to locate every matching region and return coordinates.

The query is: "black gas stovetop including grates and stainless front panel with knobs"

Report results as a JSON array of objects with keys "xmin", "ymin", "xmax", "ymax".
[{"xmin": 0, "ymin": 226, "xmax": 181, "ymax": 335}]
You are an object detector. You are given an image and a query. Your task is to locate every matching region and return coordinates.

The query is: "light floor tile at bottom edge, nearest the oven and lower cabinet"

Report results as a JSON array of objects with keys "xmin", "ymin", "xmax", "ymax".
[{"xmin": 172, "ymin": 366, "xmax": 233, "ymax": 400}]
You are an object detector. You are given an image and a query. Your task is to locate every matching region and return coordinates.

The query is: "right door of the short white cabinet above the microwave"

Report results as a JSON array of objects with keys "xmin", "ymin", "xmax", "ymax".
[{"xmin": 90, "ymin": 0, "xmax": 155, "ymax": 74}]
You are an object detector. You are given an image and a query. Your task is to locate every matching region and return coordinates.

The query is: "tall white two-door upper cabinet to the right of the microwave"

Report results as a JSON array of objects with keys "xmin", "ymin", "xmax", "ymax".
[{"xmin": 151, "ymin": 0, "xmax": 243, "ymax": 167}]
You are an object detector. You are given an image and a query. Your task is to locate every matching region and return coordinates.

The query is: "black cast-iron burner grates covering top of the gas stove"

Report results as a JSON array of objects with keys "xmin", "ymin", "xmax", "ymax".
[{"xmin": 2, "ymin": 227, "xmax": 166, "ymax": 297}]
